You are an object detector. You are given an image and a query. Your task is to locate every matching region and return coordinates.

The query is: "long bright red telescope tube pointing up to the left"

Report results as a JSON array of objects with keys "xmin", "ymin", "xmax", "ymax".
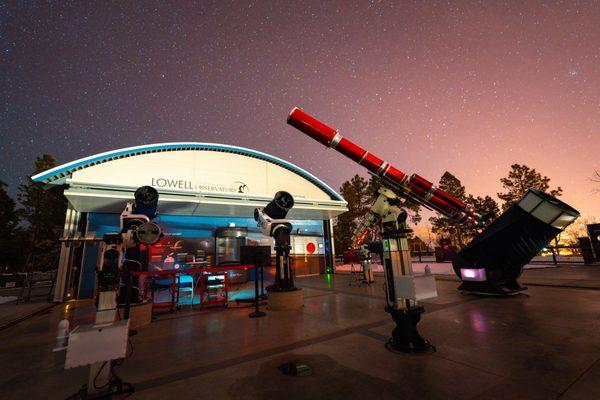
[{"xmin": 287, "ymin": 107, "xmax": 479, "ymax": 224}]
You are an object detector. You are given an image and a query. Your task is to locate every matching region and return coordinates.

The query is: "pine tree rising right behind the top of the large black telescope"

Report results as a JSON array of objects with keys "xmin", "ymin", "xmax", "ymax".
[{"xmin": 498, "ymin": 164, "xmax": 562, "ymax": 211}]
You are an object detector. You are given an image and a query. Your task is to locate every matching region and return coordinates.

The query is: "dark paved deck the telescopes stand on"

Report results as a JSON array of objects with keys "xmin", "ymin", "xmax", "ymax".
[{"xmin": 0, "ymin": 267, "xmax": 600, "ymax": 400}]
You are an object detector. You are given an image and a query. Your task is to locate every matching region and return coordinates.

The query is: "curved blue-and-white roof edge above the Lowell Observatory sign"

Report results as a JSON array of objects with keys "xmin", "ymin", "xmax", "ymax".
[{"xmin": 31, "ymin": 142, "xmax": 344, "ymax": 201}]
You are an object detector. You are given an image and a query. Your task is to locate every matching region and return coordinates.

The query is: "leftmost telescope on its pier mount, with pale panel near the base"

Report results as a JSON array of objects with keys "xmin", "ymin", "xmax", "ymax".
[{"xmin": 61, "ymin": 186, "xmax": 163, "ymax": 399}]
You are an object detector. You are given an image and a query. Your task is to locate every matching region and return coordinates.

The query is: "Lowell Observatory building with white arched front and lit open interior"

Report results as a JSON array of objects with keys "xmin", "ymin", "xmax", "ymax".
[{"xmin": 32, "ymin": 143, "xmax": 347, "ymax": 301}]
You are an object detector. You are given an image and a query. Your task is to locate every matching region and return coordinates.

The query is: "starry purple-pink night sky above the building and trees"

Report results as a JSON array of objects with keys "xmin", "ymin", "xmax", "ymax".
[{"xmin": 0, "ymin": 1, "xmax": 600, "ymax": 216}]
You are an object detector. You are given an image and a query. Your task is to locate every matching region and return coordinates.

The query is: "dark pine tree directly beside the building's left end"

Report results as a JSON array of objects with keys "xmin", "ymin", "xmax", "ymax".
[{"xmin": 18, "ymin": 154, "xmax": 67, "ymax": 270}]
